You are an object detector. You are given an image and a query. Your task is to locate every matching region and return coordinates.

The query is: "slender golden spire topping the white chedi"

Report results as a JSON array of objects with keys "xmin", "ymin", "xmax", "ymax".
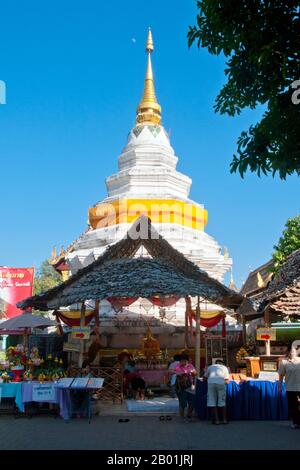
[{"xmin": 136, "ymin": 28, "xmax": 161, "ymax": 126}]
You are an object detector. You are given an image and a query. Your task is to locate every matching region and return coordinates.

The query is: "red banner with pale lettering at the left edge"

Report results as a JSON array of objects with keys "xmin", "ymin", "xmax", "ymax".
[{"xmin": 0, "ymin": 267, "xmax": 34, "ymax": 320}]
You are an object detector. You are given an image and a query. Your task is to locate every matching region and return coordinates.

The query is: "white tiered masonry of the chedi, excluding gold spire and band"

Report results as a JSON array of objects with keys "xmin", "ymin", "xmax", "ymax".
[{"xmin": 68, "ymin": 122, "xmax": 232, "ymax": 324}]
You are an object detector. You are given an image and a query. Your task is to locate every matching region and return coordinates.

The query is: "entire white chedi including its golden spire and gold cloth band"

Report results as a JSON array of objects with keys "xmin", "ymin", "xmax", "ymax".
[{"xmin": 52, "ymin": 30, "xmax": 232, "ymax": 346}]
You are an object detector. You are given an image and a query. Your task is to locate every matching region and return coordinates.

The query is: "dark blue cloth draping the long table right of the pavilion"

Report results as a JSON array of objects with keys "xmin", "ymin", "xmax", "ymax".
[{"xmin": 188, "ymin": 379, "xmax": 288, "ymax": 420}]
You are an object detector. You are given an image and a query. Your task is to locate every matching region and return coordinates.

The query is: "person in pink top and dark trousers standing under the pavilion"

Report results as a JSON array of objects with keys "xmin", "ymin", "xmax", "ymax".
[{"xmin": 174, "ymin": 354, "xmax": 197, "ymax": 418}]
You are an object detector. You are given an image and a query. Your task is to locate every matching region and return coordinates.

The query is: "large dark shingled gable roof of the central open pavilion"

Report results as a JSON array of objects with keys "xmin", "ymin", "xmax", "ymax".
[{"xmin": 18, "ymin": 216, "xmax": 244, "ymax": 310}]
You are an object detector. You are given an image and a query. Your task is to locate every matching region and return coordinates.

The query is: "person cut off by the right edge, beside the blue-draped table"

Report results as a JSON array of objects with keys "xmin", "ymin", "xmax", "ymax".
[{"xmin": 278, "ymin": 347, "xmax": 300, "ymax": 429}]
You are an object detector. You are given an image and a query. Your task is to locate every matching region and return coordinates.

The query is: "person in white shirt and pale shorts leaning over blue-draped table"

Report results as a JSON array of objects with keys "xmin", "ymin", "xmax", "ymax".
[{"xmin": 204, "ymin": 360, "xmax": 229, "ymax": 424}]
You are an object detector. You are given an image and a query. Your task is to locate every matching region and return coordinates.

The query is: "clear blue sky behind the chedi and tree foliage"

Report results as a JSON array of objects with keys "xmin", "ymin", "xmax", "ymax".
[{"xmin": 0, "ymin": 0, "xmax": 300, "ymax": 285}]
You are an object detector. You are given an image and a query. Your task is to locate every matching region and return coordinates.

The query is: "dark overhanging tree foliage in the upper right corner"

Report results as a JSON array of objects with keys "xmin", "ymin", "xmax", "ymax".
[{"xmin": 188, "ymin": 0, "xmax": 300, "ymax": 179}]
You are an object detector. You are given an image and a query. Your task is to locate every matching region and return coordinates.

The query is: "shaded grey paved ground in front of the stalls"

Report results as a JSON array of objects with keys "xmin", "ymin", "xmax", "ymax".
[{"xmin": 0, "ymin": 415, "xmax": 300, "ymax": 450}]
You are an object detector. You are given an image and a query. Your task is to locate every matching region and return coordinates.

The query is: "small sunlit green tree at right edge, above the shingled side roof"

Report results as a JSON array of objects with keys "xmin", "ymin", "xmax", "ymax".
[{"xmin": 273, "ymin": 215, "xmax": 300, "ymax": 272}]
